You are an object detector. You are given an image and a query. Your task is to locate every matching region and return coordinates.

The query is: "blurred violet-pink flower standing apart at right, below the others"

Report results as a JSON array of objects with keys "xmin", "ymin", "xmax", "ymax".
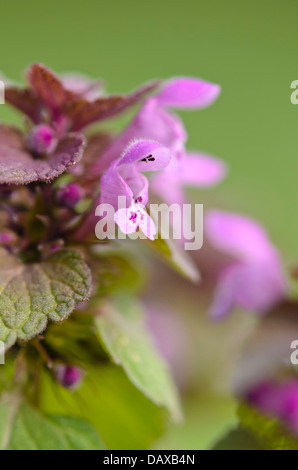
[{"xmin": 205, "ymin": 211, "xmax": 286, "ymax": 319}]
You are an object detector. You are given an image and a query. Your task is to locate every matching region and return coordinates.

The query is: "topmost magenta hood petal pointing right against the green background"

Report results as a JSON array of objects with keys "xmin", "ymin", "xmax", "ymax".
[{"xmin": 157, "ymin": 78, "xmax": 220, "ymax": 108}]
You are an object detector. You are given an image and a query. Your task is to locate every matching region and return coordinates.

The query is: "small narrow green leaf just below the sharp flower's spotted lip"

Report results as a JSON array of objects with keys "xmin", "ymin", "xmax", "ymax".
[{"xmin": 146, "ymin": 238, "xmax": 201, "ymax": 282}]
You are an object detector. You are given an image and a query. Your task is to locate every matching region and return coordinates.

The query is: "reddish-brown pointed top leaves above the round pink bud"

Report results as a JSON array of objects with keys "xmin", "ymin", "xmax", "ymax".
[{"xmin": 6, "ymin": 64, "xmax": 159, "ymax": 131}]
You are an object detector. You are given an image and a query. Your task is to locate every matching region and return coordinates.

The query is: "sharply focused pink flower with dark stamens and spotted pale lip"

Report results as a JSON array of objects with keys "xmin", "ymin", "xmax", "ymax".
[{"xmin": 100, "ymin": 140, "xmax": 171, "ymax": 239}]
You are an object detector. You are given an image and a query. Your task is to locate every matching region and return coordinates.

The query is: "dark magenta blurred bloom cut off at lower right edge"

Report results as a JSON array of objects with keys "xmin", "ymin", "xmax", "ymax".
[{"xmin": 245, "ymin": 380, "xmax": 298, "ymax": 433}]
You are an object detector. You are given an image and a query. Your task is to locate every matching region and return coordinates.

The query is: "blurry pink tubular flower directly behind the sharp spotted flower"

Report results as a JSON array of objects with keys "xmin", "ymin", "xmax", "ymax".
[{"xmin": 93, "ymin": 78, "xmax": 226, "ymax": 203}]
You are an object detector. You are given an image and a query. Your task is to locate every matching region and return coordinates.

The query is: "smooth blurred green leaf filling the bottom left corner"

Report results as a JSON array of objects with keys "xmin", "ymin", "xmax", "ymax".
[{"xmin": 0, "ymin": 400, "xmax": 105, "ymax": 450}]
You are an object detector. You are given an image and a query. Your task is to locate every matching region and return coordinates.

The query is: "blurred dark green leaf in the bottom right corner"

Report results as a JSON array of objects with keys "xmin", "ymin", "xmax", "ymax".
[{"xmin": 238, "ymin": 404, "xmax": 298, "ymax": 450}]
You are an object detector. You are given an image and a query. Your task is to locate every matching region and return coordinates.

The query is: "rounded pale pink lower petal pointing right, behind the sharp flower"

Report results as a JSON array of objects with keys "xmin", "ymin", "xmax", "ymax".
[{"xmin": 181, "ymin": 152, "xmax": 227, "ymax": 186}]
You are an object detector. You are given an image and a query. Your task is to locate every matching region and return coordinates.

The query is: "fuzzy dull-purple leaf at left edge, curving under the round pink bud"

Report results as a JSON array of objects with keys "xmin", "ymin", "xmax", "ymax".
[{"xmin": 0, "ymin": 125, "xmax": 85, "ymax": 184}]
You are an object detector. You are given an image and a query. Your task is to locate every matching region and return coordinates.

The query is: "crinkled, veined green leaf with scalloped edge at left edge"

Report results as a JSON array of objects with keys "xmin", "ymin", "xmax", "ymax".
[{"xmin": 0, "ymin": 249, "xmax": 91, "ymax": 348}]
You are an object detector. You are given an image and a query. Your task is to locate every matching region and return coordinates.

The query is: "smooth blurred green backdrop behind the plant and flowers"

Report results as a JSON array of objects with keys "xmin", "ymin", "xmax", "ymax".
[{"xmin": 0, "ymin": 0, "xmax": 298, "ymax": 449}]
